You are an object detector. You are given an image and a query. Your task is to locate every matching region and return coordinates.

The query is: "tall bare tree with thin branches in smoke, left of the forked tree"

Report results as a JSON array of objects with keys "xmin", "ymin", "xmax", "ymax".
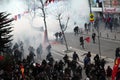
[{"xmin": 28, "ymin": 0, "xmax": 49, "ymax": 42}]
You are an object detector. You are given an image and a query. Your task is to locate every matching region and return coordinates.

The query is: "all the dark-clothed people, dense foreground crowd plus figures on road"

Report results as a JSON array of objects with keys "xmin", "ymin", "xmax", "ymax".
[{"xmin": 0, "ymin": 14, "xmax": 120, "ymax": 80}]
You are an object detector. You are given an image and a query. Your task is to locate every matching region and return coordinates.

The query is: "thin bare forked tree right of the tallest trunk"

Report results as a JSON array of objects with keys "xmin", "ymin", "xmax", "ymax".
[{"xmin": 47, "ymin": 1, "xmax": 70, "ymax": 51}]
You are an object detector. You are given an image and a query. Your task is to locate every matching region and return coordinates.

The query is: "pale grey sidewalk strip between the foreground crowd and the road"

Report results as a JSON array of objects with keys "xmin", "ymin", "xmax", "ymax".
[{"xmin": 51, "ymin": 43, "xmax": 114, "ymax": 68}]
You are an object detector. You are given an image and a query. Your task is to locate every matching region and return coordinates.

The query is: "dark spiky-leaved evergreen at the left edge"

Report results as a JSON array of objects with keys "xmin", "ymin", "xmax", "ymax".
[{"xmin": 0, "ymin": 12, "xmax": 14, "ymax": 54}]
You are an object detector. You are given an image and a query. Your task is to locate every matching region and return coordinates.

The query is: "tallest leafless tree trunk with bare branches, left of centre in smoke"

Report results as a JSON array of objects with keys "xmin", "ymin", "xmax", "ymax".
[{"xmin": 28, "ymin": 0, "xmax": 49, "ymax": 42}]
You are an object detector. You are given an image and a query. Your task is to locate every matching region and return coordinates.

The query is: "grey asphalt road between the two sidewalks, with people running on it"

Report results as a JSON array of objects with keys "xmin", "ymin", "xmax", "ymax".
[{"xmin": 65, "ymin": 33, "xmax": 120, "ymax": 59}]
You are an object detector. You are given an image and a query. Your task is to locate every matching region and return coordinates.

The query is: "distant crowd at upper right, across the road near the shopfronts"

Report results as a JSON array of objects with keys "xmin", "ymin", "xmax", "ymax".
[{"xmin": 73, "ymin": 14, "xmax": 120, "ymax": 49}]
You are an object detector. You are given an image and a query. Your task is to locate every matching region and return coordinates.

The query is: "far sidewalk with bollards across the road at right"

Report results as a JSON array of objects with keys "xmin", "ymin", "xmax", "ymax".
[{"xmin": 82, "ymin": 22, "xmax": 120, "ymax": 41}]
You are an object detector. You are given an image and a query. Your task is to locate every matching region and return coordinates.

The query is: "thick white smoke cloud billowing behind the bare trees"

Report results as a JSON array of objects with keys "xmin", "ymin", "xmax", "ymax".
[{"xmin": 0, "ymin": 0, "xmax": 89, "ymax": 55}]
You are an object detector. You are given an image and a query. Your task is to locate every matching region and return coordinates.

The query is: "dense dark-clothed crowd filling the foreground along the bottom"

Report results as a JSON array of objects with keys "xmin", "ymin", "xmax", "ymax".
[{"xmin": 0, "ymin": 42, "xmax": 116, "ymax": 80}]
